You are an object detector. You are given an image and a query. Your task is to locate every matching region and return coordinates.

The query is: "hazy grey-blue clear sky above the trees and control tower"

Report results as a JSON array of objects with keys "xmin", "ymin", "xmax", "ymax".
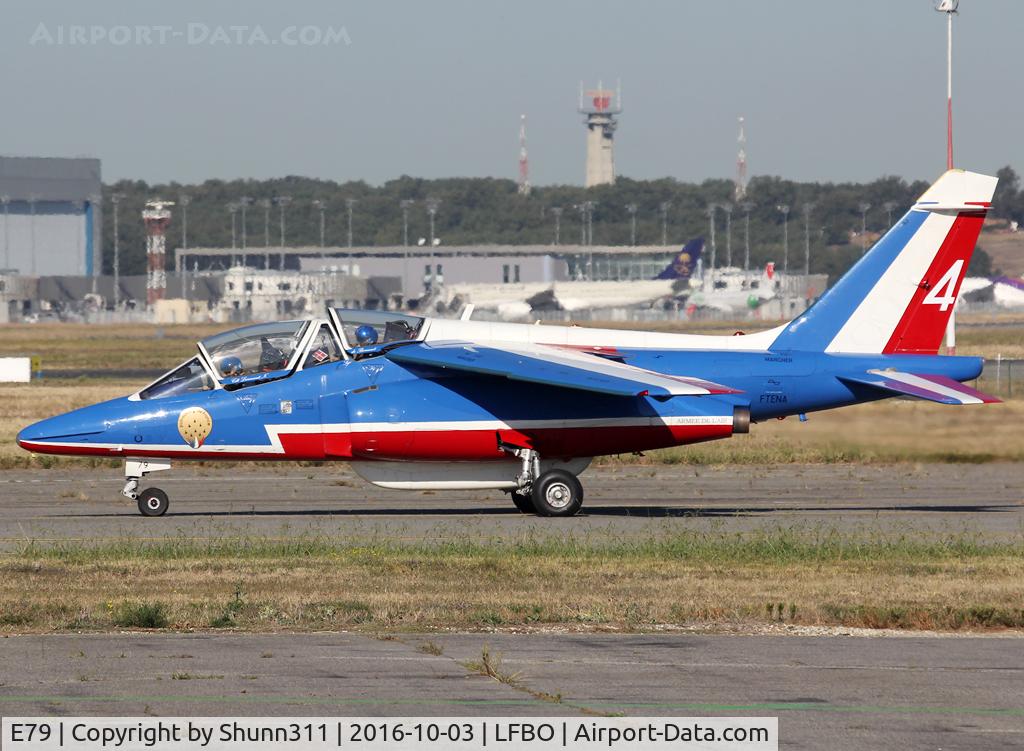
[{"xmin": 0, "ymin": 0, "xmax": 1024, "ymax": 184}]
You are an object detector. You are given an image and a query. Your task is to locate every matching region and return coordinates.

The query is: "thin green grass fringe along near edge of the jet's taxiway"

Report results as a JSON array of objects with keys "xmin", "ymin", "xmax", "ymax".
[{"xmin": 12, "ymin": 527, "xmax": 1024, "ymax": 565}]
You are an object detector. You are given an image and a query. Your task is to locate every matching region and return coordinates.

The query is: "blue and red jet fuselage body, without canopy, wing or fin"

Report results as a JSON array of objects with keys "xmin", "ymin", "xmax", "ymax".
[{"xmin": 17, "ymin": 349, "xmax": 982, "ymax": 461}]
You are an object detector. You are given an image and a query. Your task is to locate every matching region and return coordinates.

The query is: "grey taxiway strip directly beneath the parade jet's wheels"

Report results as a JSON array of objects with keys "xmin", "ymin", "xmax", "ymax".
[{"xmin": 0, "ymin": 463, "xmax": 1024, "ymax": 550}]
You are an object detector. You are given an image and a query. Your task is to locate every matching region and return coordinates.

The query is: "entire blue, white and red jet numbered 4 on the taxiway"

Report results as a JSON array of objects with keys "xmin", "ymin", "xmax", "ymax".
[{"xmin": 17, "ymin": 170, "xmax": 998, "ymax": 516}]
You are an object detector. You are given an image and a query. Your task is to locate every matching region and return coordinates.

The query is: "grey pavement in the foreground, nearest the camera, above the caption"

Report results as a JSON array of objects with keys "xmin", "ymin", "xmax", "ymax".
[{"xmin": 0, "ymin": 633, "xmax": 1024, "ymax": 751}]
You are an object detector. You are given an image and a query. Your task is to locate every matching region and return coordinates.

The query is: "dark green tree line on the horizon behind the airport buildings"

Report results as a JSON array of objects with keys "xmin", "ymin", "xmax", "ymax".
[{"xmin": 102, "ymin": 167, "xmax": 1011, "ymax": 280}]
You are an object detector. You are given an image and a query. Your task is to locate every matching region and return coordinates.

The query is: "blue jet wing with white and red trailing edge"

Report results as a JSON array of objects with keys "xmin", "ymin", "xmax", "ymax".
[{"xmin": 386, "ymin": 341, "xmax": 739, "ymax": 399}]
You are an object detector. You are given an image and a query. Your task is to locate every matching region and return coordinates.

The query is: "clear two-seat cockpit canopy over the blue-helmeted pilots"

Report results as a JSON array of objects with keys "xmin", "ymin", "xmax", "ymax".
[{"xmin": 137, "ymin": 307, "xmax": 425, "ymax": 400}]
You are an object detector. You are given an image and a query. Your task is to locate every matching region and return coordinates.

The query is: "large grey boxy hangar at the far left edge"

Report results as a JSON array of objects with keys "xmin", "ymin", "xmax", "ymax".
[{"xmin": 0, "ymin": 157, "xmax": 102, "ymax": 277}]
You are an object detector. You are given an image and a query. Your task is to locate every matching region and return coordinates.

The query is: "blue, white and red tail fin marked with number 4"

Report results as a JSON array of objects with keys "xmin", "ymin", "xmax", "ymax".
[{"xmin": 771, "ymin": 169, "xmax": 996, "ymax": 354}]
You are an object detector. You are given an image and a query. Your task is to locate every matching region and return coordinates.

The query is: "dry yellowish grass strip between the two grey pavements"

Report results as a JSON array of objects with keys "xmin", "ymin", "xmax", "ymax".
[{"xmin": 0, "ymin": 530, "xmax": 1024, "ymax": 633}]
